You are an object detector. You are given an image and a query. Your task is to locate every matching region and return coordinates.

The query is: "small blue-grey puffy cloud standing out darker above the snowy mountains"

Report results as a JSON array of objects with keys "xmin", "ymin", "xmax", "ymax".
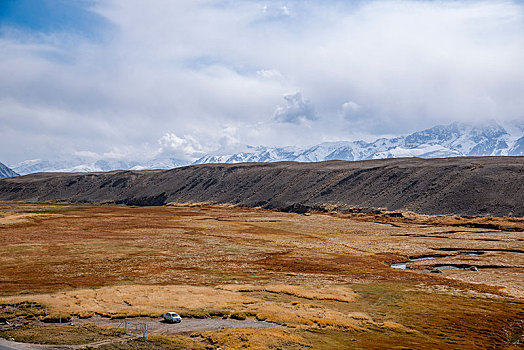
[{"xmin": 273, "ymin": 92, "xmax": 317, "ymax": 124}]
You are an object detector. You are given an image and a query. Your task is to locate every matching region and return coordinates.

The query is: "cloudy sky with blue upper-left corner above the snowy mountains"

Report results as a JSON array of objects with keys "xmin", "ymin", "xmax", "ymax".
[{"xmin": 0, "ymin": 0, "xmax": 524, "ymax": 164}]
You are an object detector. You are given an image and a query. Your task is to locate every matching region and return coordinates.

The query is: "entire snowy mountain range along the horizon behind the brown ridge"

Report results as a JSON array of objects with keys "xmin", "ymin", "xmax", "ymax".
[{"xmin": 7, "ymin": 122, "xmax": 524, "ymax": 175}]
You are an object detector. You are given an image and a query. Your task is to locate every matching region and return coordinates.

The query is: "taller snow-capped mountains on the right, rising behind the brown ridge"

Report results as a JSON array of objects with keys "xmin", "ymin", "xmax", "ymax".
[{"xmin": 195, "ymin": 122, "xmax": 524, "ymax": 164}]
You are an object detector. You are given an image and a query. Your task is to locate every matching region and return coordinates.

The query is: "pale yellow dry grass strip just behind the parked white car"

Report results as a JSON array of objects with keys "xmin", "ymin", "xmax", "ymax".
[{"xmin": 3, "ymin": 285, "xmax": 375, "ymax": 330}]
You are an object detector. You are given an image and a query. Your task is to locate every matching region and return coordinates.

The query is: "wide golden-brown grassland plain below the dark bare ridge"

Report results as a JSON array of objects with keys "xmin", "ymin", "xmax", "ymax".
[{"xmin": 0, "ymin": 202, "xmax": 524, "ymax": 349}]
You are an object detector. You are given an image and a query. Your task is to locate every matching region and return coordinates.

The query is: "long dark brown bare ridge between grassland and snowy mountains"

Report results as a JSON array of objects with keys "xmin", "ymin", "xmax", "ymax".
[{"xmin": 0, "ymin": 157, "xmax": 524, "ymax": 217}]
